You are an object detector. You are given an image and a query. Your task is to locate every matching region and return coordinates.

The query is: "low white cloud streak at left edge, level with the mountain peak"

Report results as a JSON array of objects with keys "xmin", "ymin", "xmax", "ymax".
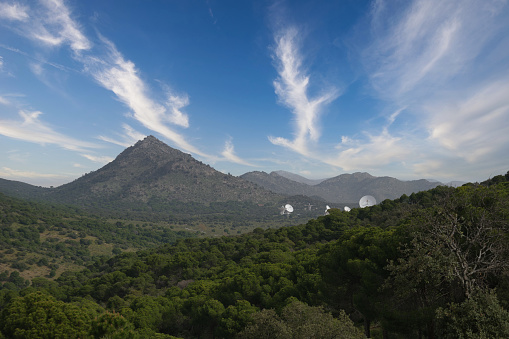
[{"xmin": 0, "ymin": 110, "xmax": 98, "ymax": 151}]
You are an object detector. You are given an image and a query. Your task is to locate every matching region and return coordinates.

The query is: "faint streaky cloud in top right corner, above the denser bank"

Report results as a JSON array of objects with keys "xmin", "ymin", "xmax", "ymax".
[{"xmin": 363, "ymin": 0, "xmax": 507, "ymax": 101}]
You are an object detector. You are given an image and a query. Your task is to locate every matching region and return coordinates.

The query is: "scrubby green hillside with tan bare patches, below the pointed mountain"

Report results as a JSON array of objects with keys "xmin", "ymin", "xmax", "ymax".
[{"xmin": 0, "ymin": 193, "xmax": 196, "ymax": 287}]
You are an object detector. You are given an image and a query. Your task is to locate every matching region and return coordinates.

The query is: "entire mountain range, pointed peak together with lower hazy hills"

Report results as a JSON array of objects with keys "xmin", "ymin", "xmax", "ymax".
[{"xmin": 0, "ymin": 136, "xmax": 456, "ymax": 216}]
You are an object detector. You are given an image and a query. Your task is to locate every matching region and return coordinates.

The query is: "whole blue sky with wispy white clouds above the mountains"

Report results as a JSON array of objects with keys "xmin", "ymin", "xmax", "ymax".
[{"xmin": 0, "ymin": 0, "xmax": 509, "ymax": 186}]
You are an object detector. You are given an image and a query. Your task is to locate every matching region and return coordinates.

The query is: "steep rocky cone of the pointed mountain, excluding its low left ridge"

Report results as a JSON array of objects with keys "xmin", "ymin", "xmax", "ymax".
[{"xmin": 51, "ymin": 136, "xmax": 280, "ymax": 205}]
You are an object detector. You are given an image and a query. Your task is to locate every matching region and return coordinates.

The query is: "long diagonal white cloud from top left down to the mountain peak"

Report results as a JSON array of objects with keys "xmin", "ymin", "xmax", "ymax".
[{"xmin": 0, "ymin": 0, "xmax": 209, "ymax": 161}]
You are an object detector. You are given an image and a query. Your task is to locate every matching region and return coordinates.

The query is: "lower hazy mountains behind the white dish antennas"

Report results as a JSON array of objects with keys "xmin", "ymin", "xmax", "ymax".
[{"xmin": 241, "ymin": 172, "xmax": 440, "ymax": 204}]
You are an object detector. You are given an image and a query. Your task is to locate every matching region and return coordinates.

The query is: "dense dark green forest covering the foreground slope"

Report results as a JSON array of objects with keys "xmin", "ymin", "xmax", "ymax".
[{"xmin": 0, "ymin": 172, "xmax": 509, "ymax": 338}]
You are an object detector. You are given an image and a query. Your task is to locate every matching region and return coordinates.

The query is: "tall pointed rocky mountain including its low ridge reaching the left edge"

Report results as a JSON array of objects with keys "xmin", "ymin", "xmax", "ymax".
[{"xmin": 0, "ymin": 136, "xmax": 294, "ymax": 221}]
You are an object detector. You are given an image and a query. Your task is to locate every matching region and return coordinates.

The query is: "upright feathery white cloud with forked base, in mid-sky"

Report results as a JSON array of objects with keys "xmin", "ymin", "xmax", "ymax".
[{"xmin": 269, "ymin": 27, "xmax": 339, "ymax": 155}]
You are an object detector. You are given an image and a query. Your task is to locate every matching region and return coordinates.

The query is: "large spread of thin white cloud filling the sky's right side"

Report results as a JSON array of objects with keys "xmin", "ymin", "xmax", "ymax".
[{"xmin": 356, "ymin": 0, "xmax": 509, "ymax": 181}]
